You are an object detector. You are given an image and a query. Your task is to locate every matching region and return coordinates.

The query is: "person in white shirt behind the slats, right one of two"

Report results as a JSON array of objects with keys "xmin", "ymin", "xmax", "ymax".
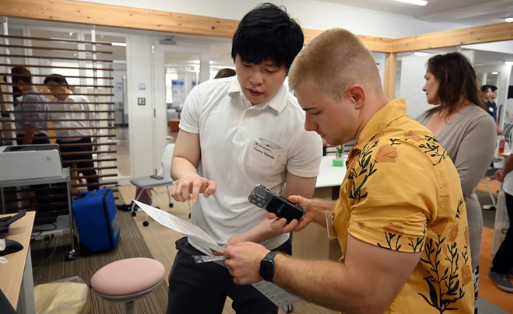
[{"xmin": 44, "ymin": 74, "xmax": 99, "ymax": 191}]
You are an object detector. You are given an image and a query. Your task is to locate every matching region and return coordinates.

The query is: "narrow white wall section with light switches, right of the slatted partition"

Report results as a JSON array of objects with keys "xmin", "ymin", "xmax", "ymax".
[{"xmin": 127, "ymin": 35, "xmax": 154, "ymax": 177}]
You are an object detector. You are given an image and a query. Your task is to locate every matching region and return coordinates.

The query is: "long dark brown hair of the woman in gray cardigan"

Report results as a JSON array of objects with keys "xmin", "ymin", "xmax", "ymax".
[{"xmin": 427, "ymin": 52, "xmax": 486, "ymax": 116}]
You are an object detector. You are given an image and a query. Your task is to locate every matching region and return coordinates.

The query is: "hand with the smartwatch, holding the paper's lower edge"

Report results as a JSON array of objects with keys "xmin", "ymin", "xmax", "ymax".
[{"xmin": 224, "ymin": 242, "xmax": 269, "ymax": 285}]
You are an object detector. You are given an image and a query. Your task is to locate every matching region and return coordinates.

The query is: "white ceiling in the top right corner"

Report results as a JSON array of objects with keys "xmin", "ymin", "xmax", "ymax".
[{"xmin": 317, "ymin": 0, "xmax": 513, "ymax": 26}]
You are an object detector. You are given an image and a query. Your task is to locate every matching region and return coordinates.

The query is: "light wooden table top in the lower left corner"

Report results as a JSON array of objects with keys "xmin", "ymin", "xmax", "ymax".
[{"xmin": 0, "ymin": 211, "xmax": 36, "ymax": 308}]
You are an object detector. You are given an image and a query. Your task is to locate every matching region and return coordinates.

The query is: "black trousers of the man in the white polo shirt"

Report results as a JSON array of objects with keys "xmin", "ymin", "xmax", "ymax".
[{"xmin": 167, "ymin": 238, "xmax": 292, "ymax": 314}]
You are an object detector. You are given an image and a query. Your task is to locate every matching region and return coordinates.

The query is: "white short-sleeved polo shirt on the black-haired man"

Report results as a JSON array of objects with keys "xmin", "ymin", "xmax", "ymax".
[{"xmin": 180, "ymin": 77, "xmax": 322, "ymax": 253}]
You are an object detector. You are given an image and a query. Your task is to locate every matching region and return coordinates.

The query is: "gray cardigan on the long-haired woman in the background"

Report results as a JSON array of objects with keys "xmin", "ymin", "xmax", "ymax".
[{"xmin": 417, "ymin": 105, "xmax": 497, "ymax": 269}]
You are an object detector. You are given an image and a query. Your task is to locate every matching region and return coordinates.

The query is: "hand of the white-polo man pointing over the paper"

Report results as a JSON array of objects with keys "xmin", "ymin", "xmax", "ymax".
[{"xmin": 171, "ymin": 173, "xmax": 217, "ymax": 203}]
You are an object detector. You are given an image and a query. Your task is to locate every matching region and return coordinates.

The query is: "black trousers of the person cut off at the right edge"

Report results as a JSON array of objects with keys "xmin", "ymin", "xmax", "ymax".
[{"xmin": 491, "ymin": 193, "xmax": 513, "ymax": 274}]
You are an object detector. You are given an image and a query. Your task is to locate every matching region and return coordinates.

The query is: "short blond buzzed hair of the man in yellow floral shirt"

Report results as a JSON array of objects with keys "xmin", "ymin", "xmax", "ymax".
[{"xmin": 289, "ymin": 28, "xmax": 382, "ymax": 101}]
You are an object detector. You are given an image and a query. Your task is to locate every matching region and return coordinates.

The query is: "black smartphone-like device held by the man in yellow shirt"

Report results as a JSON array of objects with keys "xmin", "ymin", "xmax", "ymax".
[{"xmin": 249, "ymin": 184, "xmax": 305, "ymax": 223}]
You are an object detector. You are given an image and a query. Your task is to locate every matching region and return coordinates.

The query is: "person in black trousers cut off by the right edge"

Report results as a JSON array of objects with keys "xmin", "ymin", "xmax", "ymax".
[{"xmin": 489, "ymin": 155, "xmax": 513, "ymax": 293}]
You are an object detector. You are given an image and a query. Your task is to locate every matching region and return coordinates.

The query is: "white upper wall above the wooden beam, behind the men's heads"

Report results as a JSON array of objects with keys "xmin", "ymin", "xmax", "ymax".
[{"xmin": 75, "ymin": 0, "xmax": 465, "ymax": 38}]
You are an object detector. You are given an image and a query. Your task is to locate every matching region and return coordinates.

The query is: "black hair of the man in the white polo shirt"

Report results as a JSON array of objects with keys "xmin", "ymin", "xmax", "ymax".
[{"xmin": 232, "ymin": 3, "xmax": 305, "ymax": 70}]
